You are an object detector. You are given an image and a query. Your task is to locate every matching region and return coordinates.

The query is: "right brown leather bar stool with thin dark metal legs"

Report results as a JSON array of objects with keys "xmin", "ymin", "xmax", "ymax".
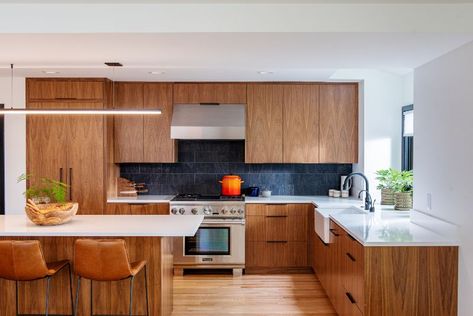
[{"xmin": 74, "ymin": 239, "xmax": 149, "ymax": 316}]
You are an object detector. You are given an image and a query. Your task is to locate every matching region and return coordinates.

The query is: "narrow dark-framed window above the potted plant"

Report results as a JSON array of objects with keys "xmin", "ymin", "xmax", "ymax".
[{"xmin": 402, "ymin": 104, "xmax": 414, "ymax": 170}]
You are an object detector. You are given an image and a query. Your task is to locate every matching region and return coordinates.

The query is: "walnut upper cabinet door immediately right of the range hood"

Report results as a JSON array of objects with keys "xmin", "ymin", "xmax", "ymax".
[{"xmin": 245, "ymin": 84, "xmax": 284, "ymax": 163}]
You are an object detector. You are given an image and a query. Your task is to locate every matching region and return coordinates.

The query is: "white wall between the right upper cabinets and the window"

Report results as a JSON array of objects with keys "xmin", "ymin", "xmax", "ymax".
[{"xmin": 331, "ymin": 69, "xmax": 412, "ymax": 202}]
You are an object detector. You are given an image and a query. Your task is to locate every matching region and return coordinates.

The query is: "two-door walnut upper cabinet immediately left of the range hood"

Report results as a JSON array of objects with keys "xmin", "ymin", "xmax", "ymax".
[{"xmin": 114, "ymin": 82, "xmax": 176, "ymax": 163}]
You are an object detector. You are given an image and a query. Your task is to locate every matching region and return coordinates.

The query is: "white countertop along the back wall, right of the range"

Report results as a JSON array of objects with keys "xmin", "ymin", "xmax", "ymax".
[{"xmin": 245, "ymin": 195, "xmax": 363, "ymax": 208}]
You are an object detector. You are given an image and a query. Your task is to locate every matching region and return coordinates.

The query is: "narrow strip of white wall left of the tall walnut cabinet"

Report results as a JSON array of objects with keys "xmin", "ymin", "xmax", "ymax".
[{"xmin": 0, "ymin": 78, "xmax": 26, "ymax": 214}]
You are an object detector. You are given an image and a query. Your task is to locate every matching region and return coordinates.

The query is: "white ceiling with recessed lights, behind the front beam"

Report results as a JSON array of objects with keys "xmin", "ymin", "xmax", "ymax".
[{"xmin": 0, "ymin": 33, "xmax": 473, "ymax": 81}]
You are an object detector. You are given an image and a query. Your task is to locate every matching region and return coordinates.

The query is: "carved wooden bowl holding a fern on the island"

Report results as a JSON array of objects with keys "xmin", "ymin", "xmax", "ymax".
[{"xmin": 25, "ymin": 200, "xmax": 79, "ymax": 226}]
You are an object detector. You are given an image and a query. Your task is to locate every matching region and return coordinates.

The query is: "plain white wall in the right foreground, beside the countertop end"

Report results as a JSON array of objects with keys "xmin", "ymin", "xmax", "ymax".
[{"xmin": 414, "ymin": 43, "xmax": 473, "ymax": 316}]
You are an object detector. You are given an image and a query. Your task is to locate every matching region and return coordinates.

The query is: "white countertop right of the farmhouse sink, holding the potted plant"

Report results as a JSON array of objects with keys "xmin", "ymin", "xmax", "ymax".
[{"xmin": 329, "ymin": 208, "xmax": 458, "ymax": 247}]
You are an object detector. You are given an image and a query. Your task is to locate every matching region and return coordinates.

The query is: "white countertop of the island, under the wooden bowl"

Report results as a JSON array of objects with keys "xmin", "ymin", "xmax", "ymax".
[{"xmin": 0, "ymin": 215, "xmax": 204, "ymax": 237}]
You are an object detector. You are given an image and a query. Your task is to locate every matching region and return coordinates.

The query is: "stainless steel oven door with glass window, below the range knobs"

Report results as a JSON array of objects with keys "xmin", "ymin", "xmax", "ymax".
[{"xmin": 174, "ymin": 219, "xmax": 245, "ymax": 265}]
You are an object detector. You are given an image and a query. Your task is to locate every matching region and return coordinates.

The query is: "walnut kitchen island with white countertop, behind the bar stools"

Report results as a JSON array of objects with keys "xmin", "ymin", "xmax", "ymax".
[{"xmin": 0, "ymin": 215, "xmax": 203, "ymax": 316}]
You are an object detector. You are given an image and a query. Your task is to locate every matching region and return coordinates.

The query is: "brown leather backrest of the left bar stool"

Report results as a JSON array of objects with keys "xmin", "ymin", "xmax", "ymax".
[{"xmin": 0, "ymin": 240, "xmax": 49, "ymax": 281}]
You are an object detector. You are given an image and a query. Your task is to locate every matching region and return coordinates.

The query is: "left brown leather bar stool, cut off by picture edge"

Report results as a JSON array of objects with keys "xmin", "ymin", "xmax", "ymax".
[{"xmin": 0, "ymin": 240, "xmax": 74, "ymax": 316}]
